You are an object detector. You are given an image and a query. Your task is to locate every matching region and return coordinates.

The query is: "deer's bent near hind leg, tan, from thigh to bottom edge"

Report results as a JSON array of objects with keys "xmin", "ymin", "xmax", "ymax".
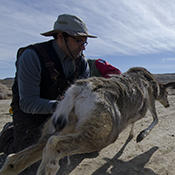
[{"xmin": 37, "ymin": 126, "xmax": 112, "ymax": 175}]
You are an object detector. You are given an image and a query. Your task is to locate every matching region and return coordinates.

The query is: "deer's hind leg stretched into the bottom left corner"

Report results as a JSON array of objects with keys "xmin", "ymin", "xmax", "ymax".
[{"xmin": 0, "ymin": 143, "xmax": 46, "ymax": 175}]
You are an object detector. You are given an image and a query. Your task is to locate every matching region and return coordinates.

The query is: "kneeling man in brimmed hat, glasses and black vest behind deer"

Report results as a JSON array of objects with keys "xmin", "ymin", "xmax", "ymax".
[{"xmin": 0, "ymin": 14, "xmax": 96, "ymax": 155}]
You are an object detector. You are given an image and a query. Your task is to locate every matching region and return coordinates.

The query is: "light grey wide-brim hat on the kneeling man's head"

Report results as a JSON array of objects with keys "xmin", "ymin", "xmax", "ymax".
[{"xmin": 41, "ymin": 14, "xmax": 97, "ymax": 38}]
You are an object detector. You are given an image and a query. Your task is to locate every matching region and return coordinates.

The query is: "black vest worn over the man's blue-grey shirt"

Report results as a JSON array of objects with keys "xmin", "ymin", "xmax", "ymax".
[{"xmin": 12, "ymin": 40, "xmax": 86, "ymax": 108}]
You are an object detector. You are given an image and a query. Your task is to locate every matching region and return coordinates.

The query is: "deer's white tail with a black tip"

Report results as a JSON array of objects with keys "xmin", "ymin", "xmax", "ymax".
[{"xmin": 52, "ymin": 85, "xmax": 82, "ymax": 131}]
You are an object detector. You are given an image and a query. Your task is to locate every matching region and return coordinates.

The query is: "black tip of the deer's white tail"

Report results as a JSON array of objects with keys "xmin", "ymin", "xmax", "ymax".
[{"xmin": 52, "ymin": 115, "xmax": 68, "ymax": 131}]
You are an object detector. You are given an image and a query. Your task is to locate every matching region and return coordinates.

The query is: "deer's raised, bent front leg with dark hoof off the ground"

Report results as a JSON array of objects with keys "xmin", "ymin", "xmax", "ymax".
[{"xmin": 137, "ymin": 97, "xmax": 158, "ymax": 142}]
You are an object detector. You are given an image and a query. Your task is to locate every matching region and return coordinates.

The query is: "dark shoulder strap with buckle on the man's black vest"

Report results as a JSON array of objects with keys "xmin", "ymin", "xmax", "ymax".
[{"xmin": 33, "ymin": 44, "xmax": 60, "ymax": 80}]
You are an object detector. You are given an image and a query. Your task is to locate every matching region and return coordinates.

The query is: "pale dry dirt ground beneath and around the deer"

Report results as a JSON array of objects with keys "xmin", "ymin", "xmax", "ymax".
[{"xmin": 0, "ymin": 74, "xmax": 175, "ymax": 175}]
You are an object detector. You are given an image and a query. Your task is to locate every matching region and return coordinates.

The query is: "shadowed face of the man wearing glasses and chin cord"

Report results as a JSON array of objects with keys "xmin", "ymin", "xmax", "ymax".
[{"xmin": 65, "ymin": 36, "xmax": 87, "ymax": 58}]
